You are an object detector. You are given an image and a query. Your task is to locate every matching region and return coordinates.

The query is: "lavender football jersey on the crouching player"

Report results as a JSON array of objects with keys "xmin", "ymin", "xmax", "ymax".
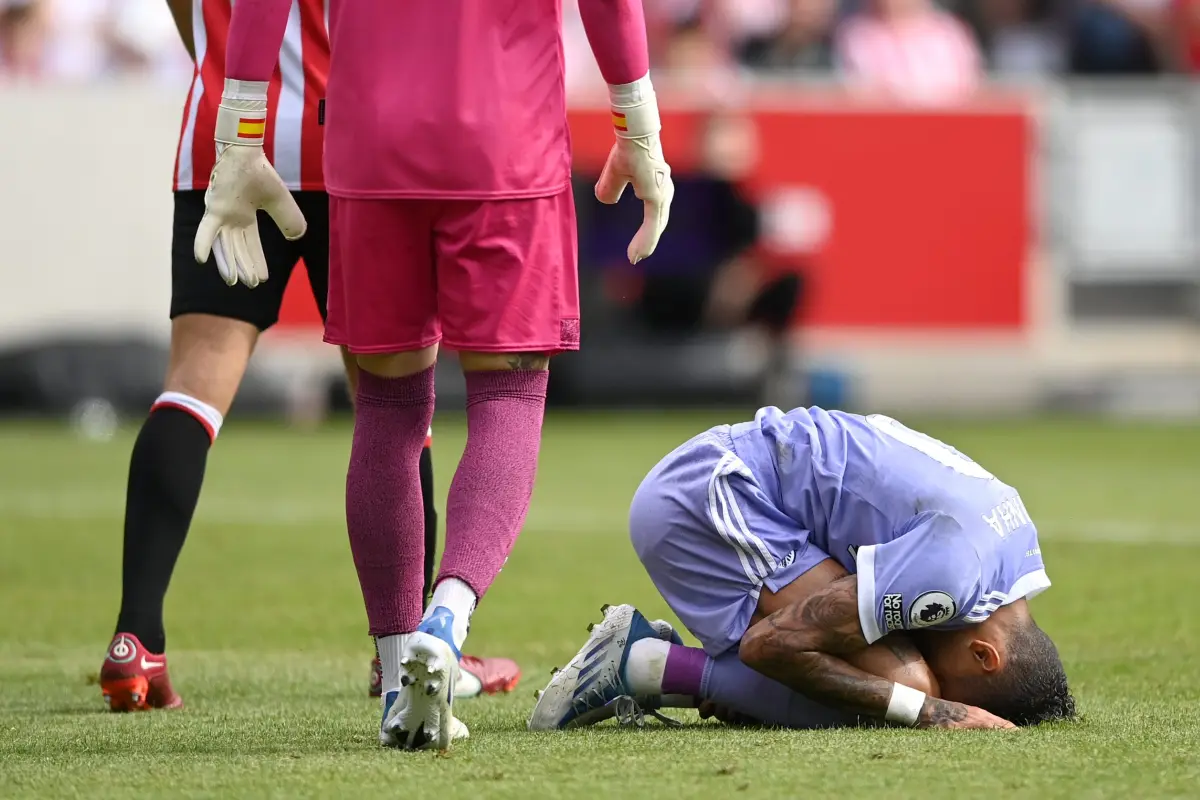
[{"xmin": 731, "ymin": 407, "xmax": 1050, "ymax": 642}]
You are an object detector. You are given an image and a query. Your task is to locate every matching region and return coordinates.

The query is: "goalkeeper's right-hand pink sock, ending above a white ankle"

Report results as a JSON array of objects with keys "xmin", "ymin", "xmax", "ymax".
[{"xmin": 438, "ymin": 369, "xmax": 550, "ymax": 597}]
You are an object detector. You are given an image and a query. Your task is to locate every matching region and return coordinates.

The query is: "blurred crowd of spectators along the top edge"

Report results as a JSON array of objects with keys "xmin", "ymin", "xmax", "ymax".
[{"xmin": 0, "ymin": 0, "xmax": 1200, "ymax": 91}]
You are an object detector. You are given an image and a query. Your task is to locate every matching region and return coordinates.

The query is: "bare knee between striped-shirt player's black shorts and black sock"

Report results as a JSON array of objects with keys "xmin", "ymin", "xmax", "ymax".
[{"xmin": 163, "ymin": 314, "xmax": 258, "ymax": 416}]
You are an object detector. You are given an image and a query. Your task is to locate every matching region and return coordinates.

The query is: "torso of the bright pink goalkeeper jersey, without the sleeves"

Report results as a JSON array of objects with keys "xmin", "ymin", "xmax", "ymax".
[{"xmin": 325, "ymin": 0, "xmax": 570, "ymax": 199}]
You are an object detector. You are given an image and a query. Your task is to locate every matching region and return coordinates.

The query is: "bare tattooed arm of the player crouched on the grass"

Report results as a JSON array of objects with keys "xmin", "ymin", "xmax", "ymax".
[{"xmin": 740, "ymin": 576, "xmax": 984, "ymax": 728}]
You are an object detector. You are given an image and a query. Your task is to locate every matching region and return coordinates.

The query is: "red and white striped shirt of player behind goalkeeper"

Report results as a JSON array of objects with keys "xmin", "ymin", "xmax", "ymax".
[{"xmin": 174, "ymin": 0, "xmax": 329, "ymax": 192}]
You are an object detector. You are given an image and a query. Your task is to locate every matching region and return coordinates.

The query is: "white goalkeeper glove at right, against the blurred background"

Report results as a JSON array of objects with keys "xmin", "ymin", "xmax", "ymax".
[{"xmin": 596, "ymin": 76, "xmax": 674, "ymax": 264}]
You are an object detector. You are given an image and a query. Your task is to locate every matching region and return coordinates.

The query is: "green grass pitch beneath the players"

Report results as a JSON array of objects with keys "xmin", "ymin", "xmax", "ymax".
[{"xmin": 0, "ymin": 414, "xmax": 1200, "ymax": 800}]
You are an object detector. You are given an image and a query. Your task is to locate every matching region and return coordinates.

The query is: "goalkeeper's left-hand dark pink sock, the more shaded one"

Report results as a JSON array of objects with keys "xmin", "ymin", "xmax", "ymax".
[{"xmin": 346, "ymin": 367, "xmax": 433, "ymax": 636}]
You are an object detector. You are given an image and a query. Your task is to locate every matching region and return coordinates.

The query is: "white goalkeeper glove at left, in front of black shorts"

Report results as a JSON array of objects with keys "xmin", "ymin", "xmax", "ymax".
[{"xmin": 192, "ymin": 79, "xmax": 307, "ymax": 289}]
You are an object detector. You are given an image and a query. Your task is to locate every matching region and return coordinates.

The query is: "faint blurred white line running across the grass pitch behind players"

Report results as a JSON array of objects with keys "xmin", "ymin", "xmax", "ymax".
[{"xmin": 0, "ymin": 491, "xmax": 1200, "ymax": 547}]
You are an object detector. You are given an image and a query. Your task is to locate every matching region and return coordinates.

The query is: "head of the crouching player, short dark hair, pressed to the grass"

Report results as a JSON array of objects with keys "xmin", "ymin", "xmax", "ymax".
[{"xmin": 966, "ymin": 619, "xmax": 1075, "ymax": 727}]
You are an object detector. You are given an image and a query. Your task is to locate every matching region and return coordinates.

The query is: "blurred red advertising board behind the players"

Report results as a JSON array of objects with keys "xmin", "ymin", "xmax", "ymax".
[{"xmin": 282, "ymin": 92, "xmax": 1034, "ymax": 332}]
